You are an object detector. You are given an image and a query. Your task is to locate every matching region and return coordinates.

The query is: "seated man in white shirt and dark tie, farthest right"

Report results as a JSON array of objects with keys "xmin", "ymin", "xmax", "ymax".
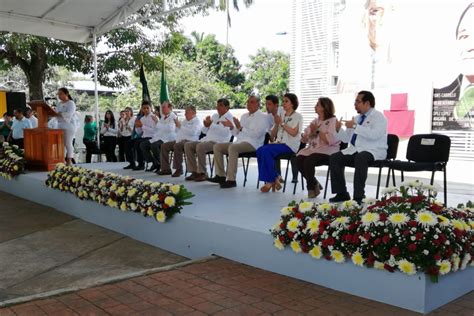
[{"xmin": 329, "ymin": 91, "xmax": 388, "ymax": 204}]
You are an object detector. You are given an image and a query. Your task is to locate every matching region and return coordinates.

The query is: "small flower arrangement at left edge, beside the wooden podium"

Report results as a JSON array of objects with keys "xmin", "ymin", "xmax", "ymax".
[{"xmin": 0, "ymin": 142, "xmax": 26, "ymax": 180}]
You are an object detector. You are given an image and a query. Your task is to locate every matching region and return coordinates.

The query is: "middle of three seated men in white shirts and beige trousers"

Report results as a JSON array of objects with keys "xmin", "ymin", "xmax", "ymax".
[{"xmin": 184, "ymin": 99, "xmax": 233, "ymax": 181}]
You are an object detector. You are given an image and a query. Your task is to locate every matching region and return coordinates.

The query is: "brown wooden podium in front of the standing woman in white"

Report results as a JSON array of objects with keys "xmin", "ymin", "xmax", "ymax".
[{"xmin": 24, "ymin": 100, "xmax": 64, "ymax": 171}]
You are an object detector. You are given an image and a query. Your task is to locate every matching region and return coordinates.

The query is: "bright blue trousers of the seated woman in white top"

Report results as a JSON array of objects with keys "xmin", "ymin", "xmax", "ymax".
[{"xmin": 257, "ymin": 144, "xmax": 294, "ymax": 182}]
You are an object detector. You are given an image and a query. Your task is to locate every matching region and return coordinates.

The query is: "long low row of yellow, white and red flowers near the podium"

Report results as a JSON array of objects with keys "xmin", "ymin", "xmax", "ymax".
[{"xmin": 46, "ymin": 164, "xmax": 194, "ymax": 223}]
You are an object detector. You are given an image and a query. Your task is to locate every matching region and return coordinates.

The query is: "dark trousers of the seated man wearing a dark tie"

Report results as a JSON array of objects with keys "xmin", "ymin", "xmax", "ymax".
[{"xmin": 329, "ymin": 151, "xmax": 374, "ymax": 199}]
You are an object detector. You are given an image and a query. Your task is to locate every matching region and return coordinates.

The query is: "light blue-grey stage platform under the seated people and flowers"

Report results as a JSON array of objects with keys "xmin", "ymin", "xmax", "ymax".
[{"xmin": 0, "ymin": 163, "xmax": 474, "ymax": 313}]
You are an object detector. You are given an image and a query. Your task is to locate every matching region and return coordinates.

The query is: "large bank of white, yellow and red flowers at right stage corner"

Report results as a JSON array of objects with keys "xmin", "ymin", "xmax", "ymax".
[{"xmin": 270, "ymin": 181, "xmax": 474, "ymax": 282}]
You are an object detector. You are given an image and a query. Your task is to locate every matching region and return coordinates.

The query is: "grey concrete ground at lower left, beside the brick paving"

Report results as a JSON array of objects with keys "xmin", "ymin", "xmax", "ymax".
[{"xmin": 0, "ymin": 192, "xmax": 188, "ymax": 303}]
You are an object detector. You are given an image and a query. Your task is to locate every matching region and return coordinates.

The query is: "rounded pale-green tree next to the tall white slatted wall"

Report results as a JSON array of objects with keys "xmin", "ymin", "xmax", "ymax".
[{"xmin": 245, "ymin": 48, "xmax": 290, "ymax": 97}]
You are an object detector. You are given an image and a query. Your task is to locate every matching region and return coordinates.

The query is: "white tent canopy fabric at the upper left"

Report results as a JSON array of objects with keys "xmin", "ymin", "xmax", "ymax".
[{"xmin": 0, "ymin": 0, "xmax": 150, "ymax": 43}]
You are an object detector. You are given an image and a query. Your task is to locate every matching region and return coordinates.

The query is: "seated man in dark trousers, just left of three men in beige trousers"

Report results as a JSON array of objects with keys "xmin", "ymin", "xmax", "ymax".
[{"xmin": 140, "ymin": 101, "xmax": 176, "ymax": 171}]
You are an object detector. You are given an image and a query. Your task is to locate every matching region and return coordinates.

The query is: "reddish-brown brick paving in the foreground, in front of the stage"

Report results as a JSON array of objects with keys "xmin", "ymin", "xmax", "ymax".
[{"xmin": 0, "ymin": 259, "xmax": 474, "ymax": 316}]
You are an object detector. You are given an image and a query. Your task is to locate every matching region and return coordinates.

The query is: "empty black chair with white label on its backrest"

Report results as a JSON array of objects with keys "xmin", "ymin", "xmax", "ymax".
[{"xmin": 389, "ymin": 134, "xmax": 451, "ymax": 206}]
